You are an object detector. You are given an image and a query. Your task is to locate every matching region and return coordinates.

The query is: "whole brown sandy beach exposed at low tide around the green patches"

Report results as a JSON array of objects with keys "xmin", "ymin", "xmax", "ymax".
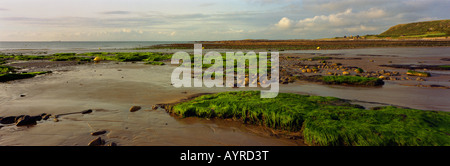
[{"xmin": 0, "ymin": 47, "xmax": 450, "ymax": 146}]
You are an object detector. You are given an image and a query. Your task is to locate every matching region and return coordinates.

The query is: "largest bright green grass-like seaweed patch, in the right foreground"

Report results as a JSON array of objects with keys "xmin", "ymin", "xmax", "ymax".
[{"xmin": 166, "ymin": 91, "xmax": 450, "ymax": 146}]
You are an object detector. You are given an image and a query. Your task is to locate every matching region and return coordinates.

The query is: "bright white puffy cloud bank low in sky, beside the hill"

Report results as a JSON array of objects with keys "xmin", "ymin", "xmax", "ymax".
[{"xmin": 275, "ymin": 7, "xmax": 392, "ymax": 38}]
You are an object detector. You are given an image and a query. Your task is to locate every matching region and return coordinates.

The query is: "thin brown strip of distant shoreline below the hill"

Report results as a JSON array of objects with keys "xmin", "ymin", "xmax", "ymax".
[{"xmin": 146, "ymin": 39, "xmax": 450, "ymax": 51}]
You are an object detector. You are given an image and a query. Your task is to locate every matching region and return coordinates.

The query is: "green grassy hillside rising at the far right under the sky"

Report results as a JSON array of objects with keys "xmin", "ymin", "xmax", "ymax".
[{"xmin": 378, "ymin": 20, "xmax": 450, "ymax": 37}]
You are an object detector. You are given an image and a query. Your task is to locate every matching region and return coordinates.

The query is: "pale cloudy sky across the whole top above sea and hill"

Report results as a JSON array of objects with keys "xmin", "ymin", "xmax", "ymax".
[{"xmin": 0, "ymin": 0, "xmax": 450, "ymax": 41}]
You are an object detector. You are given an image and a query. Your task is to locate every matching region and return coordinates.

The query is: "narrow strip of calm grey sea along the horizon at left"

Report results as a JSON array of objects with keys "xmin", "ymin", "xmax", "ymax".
[{"xmin": 0, "ymin": 41, "xmax": 189, "ymax": 50}]
